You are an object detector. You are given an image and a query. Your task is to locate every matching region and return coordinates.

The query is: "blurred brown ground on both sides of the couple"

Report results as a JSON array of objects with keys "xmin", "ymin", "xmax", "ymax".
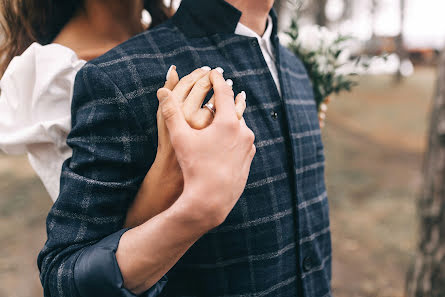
[{"xmin": 0, "ymin": 68, "xmax": 435, "ymax": 297}]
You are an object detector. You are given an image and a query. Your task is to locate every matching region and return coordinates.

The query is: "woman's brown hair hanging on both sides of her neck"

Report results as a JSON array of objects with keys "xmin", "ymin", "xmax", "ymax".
[{"xmin": 0, "ymin": 0, "xmax": 171, "ymax": 77}]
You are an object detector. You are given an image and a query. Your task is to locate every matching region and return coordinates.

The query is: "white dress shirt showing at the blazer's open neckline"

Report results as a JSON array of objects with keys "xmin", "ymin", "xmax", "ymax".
[{"xmin": 235, "ymin": 16, "xmax": 281, "ymax": 96}]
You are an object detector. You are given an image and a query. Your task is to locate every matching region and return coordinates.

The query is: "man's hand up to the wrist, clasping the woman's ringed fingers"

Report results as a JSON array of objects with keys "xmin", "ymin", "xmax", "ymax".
[{"xmin": 158, "ymin": 71, "xmax": 256, "ymax": 229}]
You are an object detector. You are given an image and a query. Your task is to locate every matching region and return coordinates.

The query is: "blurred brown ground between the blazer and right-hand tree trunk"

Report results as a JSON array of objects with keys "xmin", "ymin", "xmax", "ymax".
[{"xmin": 323, "ymin": 69, "xmax": 435, "ymax": 297}]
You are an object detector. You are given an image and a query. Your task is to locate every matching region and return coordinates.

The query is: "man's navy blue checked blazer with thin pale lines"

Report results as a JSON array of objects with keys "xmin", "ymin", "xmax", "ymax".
[{"xmin": 38, "ymin": 0, "xmax": 331, "ymax": 297}]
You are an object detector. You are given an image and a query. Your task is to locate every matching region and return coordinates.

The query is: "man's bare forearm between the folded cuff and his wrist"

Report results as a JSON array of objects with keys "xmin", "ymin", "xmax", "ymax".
[{"xmin": 116, "ymin": 194, "xmax": 211, "ymax": 294}]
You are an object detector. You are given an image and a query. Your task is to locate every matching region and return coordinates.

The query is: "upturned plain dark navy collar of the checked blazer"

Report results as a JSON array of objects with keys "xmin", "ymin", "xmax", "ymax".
[{"xmin": 172, "ymin": 0, "xmax": 277, "ymax": 37}]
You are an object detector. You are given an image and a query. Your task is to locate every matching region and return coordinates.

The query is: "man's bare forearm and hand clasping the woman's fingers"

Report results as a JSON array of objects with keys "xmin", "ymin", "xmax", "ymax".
[{"xmin": 116, "ymin": 71, "xmax": 256, "ymax": 294}]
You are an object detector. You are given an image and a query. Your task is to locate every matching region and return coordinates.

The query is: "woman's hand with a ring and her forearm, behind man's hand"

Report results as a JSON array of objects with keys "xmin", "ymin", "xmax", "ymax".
[{"xmin": 125, "ymin": 66, "xmax": 246, "ymax": 227}]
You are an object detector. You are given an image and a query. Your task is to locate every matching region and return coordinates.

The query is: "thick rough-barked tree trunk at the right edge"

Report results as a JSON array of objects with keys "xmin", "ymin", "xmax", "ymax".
[{"xmin": 406, "ymin": 51, "xmax": 445, "ymax": 297}]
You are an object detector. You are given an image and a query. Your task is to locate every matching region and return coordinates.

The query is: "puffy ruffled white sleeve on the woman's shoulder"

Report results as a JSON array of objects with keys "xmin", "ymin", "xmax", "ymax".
[{"xmin": 0, "ymin": 43, "xmax": 85, "ymax": 200}]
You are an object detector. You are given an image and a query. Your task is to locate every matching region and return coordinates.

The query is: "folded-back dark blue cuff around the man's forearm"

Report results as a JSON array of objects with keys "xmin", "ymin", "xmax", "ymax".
[{"xmin": 74, "ymin": 229, "xmax": 167, "ymax": 297}]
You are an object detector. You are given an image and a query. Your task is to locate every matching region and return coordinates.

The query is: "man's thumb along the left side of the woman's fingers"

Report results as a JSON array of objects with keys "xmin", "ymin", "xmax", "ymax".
[{"xmin": 157, "ymin": 88, "xmax": 190, "ymax": 138}]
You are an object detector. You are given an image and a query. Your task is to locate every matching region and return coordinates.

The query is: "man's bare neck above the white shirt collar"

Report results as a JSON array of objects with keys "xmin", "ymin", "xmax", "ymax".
[{"xmin": 226, "ymin": 0, "xmax": 274, "ymax": 36}]
